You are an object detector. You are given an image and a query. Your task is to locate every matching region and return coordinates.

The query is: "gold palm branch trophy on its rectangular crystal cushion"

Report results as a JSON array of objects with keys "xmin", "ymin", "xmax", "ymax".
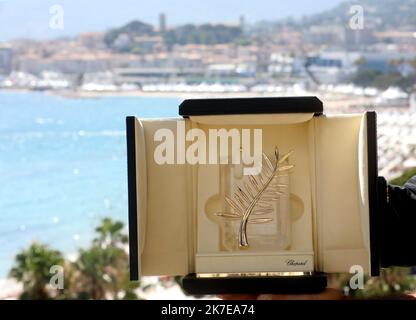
[{"xmin": 215, "ymin": 148, "xmax": 293, "ymax": 255}]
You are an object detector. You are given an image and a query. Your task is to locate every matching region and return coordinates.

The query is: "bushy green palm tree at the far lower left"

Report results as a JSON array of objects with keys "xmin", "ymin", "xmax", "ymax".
[{"xmin": 9, "ymin": 242, "xmax": 64, "ymax": 299}]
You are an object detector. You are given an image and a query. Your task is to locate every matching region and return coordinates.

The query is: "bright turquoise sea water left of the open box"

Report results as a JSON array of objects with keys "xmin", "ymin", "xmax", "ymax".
[{"xmin": 0, "ymin": 92, "xmax": 180, "ymax": 277}]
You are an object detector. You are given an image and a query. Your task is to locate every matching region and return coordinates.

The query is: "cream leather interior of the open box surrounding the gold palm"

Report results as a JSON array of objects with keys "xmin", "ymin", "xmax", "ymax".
[{"xmin": 127, "ymin": 98, "xmax": 378, "ymax": 279}]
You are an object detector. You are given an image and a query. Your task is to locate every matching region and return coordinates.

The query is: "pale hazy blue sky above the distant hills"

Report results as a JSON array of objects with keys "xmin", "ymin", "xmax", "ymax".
[{"xmin": 0, "ymin": 0, "xmax": 342, "ymax": 42}]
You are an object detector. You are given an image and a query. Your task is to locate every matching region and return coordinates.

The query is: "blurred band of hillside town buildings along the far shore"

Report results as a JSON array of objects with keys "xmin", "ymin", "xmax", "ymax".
[{"xmin": 0, "ymin": 11, "xmax": 416, "ymax": 110}]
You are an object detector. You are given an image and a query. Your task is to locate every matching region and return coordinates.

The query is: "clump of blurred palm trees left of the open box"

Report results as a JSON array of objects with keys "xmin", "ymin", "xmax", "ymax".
[{"xmin": 10, "ymin": 218, "xmax": 140, "ymax": 299}]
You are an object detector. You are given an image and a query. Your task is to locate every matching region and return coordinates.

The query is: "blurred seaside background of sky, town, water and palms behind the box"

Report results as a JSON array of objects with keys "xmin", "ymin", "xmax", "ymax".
[{"xmin": 0, "ymin": 0, "xmax": 416, "ymax": 299}]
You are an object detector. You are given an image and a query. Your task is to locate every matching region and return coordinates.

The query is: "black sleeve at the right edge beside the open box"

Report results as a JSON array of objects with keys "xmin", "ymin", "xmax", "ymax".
[{"xmin": 380, "ymin": 176, "xmax": 416, "ymax": 267}]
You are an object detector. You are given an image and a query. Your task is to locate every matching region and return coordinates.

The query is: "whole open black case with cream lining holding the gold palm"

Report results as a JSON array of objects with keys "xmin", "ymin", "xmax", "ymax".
[{"xmin": 127, "ymin": 97, "xmax": 380, "ymax": 295}]
